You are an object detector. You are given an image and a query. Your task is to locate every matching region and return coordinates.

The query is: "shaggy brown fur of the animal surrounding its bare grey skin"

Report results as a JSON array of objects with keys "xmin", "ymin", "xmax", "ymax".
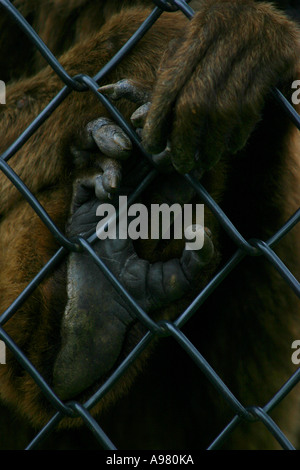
[{"xmin": 0, "ymin": 0, "xmax": 300, "ymax": 449}]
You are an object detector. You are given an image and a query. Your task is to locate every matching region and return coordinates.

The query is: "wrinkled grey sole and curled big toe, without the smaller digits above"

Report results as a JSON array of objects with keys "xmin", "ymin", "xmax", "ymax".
[{"xmin": 53, "ymin": 179, "xmax": 214, "ymax": 399}]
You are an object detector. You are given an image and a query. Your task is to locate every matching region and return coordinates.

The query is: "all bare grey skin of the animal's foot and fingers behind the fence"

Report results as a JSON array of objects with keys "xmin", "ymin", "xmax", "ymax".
[{"xmin": 53, "ymin": 80, "xmax": 214, "ymax": 399}]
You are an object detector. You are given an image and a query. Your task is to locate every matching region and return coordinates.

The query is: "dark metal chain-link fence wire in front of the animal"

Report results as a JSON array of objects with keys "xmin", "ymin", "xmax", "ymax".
[{"xmin": 0, "ymin": 0, "xmax": 300, "ymax": 450}]
